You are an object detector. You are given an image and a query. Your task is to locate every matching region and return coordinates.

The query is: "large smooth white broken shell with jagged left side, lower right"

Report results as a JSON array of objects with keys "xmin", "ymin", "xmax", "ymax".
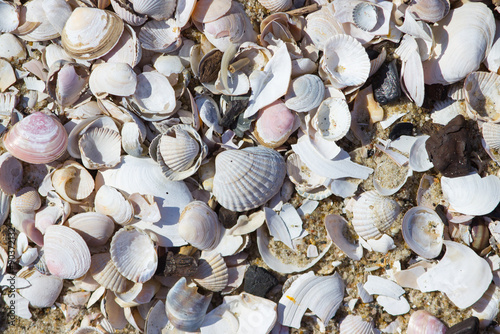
[{"xmin": 417, "ymin": 240, "xmax": 493, "ymax": 309}]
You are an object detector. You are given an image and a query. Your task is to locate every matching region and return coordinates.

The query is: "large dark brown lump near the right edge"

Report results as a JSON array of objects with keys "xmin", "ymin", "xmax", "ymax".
[{"xmin": 425, "ymin": 115, "xmax": 472, "ymax": 177}]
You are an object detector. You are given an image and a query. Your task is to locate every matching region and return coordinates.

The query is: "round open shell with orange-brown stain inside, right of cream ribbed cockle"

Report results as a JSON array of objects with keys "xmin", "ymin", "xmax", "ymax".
[{"xmin": 402, "ymin": 206, "xmax": 444, "ymax": 259}]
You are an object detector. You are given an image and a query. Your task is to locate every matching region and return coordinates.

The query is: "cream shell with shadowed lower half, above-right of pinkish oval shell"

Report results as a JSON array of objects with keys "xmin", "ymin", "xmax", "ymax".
[{"xmin": 68, "ymin": 212, "xmax": 115, "ymax": 246}]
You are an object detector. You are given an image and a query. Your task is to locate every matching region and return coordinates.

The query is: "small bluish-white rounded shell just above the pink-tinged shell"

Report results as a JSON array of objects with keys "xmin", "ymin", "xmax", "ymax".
[{"xmin": 285, "ymin": 74, "xmax": 325, "ymax": 112}]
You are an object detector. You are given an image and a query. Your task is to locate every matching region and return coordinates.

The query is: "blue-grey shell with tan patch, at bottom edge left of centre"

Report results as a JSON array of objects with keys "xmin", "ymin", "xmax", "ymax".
[{"xmin": 165, "ymin": 277, "xmax": 212, "ymax": 332}]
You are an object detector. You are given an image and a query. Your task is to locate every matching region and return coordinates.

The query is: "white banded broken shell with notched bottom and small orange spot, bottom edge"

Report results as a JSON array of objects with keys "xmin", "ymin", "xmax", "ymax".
[{"xmin": 278, "ymin": 271, "xmax": 345, "ymax": 328}]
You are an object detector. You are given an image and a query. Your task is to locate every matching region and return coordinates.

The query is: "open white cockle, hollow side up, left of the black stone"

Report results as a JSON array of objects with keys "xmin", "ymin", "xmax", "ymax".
[{"xmin": 320, "ymin": 34, "xmax": 370, "ymax": 89}]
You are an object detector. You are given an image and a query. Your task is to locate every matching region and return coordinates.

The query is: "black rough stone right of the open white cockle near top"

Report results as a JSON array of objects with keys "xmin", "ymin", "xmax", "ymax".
[{"xmin": 372, "ymin": 60, "xmax": 401, "ymax": 105}]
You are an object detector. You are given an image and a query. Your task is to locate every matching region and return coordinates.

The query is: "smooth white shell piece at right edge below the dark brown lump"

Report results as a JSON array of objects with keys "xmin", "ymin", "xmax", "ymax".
[{"xmin": 441, "ymin": 173, "xmax": 500, "ymax": 216}]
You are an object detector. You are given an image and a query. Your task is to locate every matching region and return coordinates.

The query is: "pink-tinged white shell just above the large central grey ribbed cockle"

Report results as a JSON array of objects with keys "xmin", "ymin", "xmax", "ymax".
[{"xmin": 254, "ymin": 100, "xmax": 296, "ymax": 148}]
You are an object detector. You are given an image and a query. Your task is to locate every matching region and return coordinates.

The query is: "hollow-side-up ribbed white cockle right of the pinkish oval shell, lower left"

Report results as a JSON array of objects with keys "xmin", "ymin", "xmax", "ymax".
[{"xmin": 110, "ymin": 227, "xmax": 158, "ymax": 283}]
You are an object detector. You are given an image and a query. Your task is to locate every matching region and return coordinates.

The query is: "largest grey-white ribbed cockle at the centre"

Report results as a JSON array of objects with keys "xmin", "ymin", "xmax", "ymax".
[{"xmin": 213, "ymin": 147, "xmax": 286, "ymax": 211}]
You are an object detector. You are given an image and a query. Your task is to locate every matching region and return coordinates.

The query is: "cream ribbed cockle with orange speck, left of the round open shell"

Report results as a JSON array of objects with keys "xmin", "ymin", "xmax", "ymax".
[{"xmin": 352, "ymin": 190, "xmax": 400, "ymax": 240}]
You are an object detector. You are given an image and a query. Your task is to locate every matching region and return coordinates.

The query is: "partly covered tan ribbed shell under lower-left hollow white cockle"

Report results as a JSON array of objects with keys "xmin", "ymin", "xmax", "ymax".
[{"xmin": 89, "ymin": 253, "xmax": 134, "ymax": 293}]
